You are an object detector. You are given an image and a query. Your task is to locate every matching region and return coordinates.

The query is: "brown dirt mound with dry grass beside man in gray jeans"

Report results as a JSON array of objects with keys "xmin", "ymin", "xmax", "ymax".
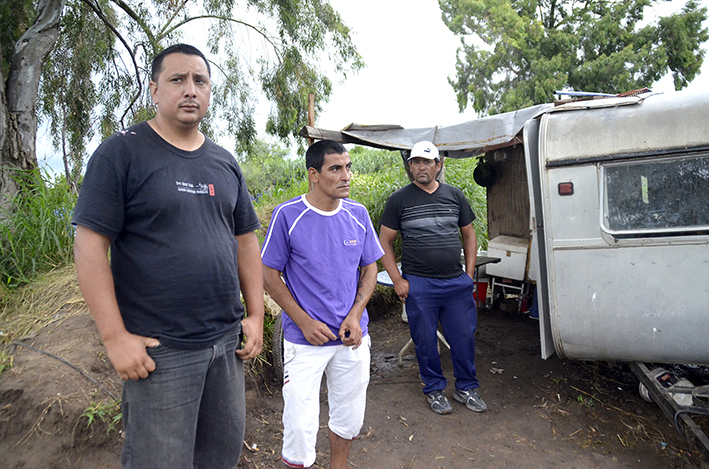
[{"xmin": 0, "ymin": 311, "xmax": 122, "ymax": 468}]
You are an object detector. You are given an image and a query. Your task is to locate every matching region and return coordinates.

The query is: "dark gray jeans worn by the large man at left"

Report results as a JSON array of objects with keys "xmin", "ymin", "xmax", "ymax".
[{"xmin": 121, "ymin": 327, "xmax": 245, "ymax": 469}]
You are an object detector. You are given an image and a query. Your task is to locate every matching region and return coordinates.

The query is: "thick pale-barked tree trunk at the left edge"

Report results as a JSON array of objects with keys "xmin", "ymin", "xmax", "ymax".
[{"xmin": 0, "ymin": 0, "xmax": 66, "ymax": 210}]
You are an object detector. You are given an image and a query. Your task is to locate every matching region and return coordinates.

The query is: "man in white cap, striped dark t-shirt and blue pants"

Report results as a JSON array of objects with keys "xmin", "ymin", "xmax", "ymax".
[{"xmin": 379, "ymin": 141, "xmax": 487, "ymax": 414}]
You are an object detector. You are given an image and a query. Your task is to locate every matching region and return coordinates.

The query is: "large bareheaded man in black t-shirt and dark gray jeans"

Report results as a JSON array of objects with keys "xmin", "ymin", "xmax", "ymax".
[{"xmin": 72, "ymin": 44, "xmax": 264, "ymax": 469}]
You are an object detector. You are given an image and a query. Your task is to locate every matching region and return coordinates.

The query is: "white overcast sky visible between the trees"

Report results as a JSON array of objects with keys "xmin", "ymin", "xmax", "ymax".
[{"xmin": 37, "ymin": 0, "xmax": 709, "ymax": 171}]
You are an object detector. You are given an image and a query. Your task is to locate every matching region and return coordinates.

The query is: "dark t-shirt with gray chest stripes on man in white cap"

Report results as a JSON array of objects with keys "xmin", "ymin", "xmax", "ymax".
[{"xmin": 380, "ymin": 183, "xmax": 475, "ymax": 279}]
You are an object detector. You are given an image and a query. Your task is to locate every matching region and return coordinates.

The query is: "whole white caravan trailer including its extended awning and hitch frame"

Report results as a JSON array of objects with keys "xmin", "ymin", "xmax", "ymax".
[{"xmin": 301, "ymin": 88, "xmax": 709, "ymax": 454}]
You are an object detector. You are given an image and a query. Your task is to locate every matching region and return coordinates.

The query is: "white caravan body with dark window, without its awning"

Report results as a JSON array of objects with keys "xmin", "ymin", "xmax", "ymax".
[{"xmin": 524, "ymin": 89, "xmax": 709, "ymax": 365}]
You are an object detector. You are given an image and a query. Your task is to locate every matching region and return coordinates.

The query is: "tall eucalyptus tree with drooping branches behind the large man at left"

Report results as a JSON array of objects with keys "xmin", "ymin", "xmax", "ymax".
[{"xmin": 0, "ymin": 0, "xmax": 363, "ymax": 206}]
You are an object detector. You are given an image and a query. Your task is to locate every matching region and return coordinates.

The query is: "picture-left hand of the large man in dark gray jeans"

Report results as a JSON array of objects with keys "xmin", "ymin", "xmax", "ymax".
[{"xmin": 103, "ymin": 332, "xmax": 160, "ymax": 381}]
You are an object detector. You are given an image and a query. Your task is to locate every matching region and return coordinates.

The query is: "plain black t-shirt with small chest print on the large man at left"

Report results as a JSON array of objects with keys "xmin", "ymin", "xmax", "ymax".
[{"xmin": 72, "ymin": 122, "xmax": 260, "ymax": 348}]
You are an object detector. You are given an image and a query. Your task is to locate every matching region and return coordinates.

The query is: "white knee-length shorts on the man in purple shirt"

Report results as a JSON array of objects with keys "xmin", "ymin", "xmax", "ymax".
[{"xmin": 281, "ymin": 335, "xmax": 372, "ymax": 467}]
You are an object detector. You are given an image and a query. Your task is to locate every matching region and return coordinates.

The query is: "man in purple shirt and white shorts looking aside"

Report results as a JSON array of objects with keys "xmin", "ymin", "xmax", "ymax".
[{"xmin": 261, "ymin": 140, "xmax": 384, "ymax": 469}]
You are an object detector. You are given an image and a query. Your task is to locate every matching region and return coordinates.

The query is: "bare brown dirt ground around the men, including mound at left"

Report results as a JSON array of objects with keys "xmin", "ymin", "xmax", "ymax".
[{"xmin": 0, "ymin": 296, "xmax": 707, "ymax": 469}]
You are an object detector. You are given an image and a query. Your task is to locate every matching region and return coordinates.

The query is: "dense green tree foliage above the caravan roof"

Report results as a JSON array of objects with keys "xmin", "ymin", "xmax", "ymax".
[{"xmin": 439, "ymin": 0, "xmax": 709, "ymax": 114}]
